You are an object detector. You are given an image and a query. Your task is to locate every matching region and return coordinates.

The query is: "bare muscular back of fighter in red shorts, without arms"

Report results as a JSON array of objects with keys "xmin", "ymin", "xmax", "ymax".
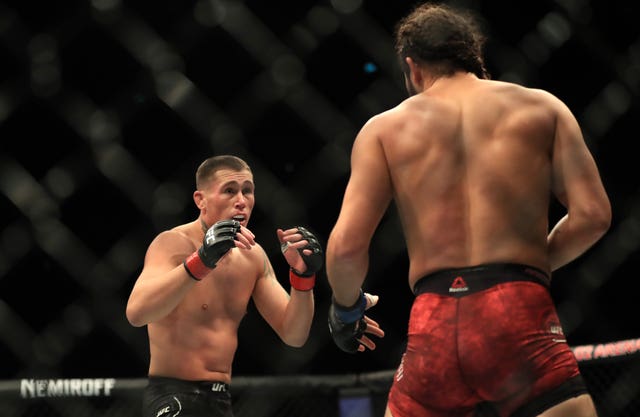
[{"xmin": 379, "ymin": 74, "xmax": 557, "ymax": 285}]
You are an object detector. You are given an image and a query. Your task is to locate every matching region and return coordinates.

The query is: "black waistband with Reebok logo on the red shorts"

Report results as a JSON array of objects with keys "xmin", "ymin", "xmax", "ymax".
[{"xmin": 413, "ymin": 263, "xmax": 551, "ymax": 297}]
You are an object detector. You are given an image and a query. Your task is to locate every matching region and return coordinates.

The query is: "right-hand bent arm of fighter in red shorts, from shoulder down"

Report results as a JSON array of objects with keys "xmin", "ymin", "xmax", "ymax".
[{"xmin": 547, "ymin": 99, "xmax": 611, "ymax": 270}]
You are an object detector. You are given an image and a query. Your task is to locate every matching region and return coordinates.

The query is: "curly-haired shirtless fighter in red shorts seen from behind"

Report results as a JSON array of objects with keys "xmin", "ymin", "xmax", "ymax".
[{"xmin": 326, "ymin": 3, "xmax": 611, "ymax": 417}]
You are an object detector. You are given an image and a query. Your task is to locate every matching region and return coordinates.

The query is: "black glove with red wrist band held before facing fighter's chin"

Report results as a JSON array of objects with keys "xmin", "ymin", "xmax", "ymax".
[{"xmin": 182, "ymin": 220, "xmax": 240, "ymax": 281}]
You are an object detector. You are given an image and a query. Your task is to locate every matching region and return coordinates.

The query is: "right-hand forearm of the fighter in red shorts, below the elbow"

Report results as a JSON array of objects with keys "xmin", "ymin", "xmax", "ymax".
[{"xmin": 547, "ymin": 214, "xmax": 609, "ymax": 271}]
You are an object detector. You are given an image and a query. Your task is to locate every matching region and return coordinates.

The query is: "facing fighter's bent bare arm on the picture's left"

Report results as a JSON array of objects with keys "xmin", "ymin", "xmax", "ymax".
[{"xmin": 127, "ymin": 231, "xmax": 196, "ymax": 327}]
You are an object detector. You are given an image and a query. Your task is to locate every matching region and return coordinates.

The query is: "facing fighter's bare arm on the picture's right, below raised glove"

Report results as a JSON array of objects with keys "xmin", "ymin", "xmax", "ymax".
[{"xmin": 253, "ymin": 250, "xmax": 314, "ymax": 347}]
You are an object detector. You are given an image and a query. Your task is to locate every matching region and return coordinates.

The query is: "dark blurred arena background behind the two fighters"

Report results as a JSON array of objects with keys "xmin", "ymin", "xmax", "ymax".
[{"xmin": 0, "ymin": 0, "xmax": 640, "ymax": 417}]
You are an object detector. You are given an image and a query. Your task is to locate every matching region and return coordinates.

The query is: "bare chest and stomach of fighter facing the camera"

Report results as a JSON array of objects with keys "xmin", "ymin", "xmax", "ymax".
[{"xmin": 148, "ymin": 222, "xmax": 263, "ymax": 383}]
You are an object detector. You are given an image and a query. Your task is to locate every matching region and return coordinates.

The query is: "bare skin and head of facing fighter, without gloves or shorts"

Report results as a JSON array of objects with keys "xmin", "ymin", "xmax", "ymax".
[{"xmin": 127, "ymin": 169, "xmax": 314, "ymax": 383}]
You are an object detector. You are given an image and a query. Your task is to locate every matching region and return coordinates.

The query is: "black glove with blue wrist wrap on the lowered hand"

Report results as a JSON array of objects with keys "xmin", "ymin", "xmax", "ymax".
[{"xmin": 329, "ymin": 290, "xmax": 367, "ymax": 353}]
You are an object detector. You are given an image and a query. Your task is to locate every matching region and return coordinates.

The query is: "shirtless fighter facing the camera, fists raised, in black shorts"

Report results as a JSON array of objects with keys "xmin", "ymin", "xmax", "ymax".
[{"xmin": 127, "ymin": 155, "xmax": 323, "ymax": 417}]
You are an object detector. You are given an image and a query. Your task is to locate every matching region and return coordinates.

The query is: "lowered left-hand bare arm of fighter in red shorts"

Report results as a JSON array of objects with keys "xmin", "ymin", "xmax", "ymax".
[{"xmin": 326, "ymin": 119, "xmax": 392, "ymax": 306}]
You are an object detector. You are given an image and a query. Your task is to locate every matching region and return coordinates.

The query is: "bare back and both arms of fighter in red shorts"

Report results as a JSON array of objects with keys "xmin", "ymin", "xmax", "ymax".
[{"xmin": 327, "ymin": 72, "xmax": 610, "ymax": 305}]
